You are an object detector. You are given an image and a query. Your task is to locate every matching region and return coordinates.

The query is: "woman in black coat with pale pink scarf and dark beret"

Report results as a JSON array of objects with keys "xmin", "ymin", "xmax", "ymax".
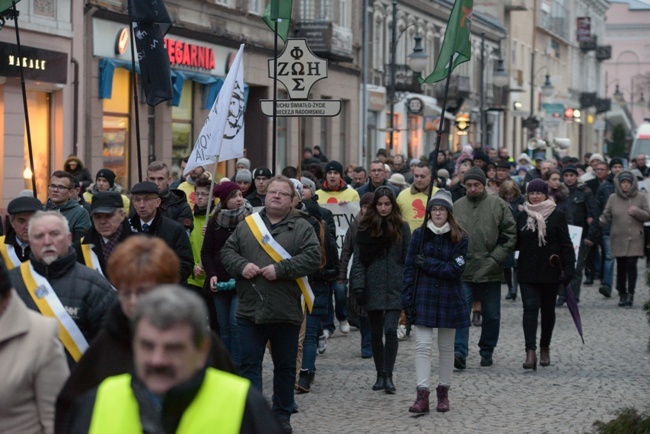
[{"xmin": 515, "ymin": 179, "xmax": 575, "ymax": 370}]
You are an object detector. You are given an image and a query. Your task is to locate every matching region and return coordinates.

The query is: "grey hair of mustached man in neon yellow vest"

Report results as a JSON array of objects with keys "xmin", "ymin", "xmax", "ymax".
[{"xmin": 131, "ymin": 285, "xmax": 209, "ymax": 348}]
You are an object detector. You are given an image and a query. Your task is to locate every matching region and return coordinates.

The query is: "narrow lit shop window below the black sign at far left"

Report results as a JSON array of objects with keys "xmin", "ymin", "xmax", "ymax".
[{"xmin": 24, "ymin": 92, "xmax": 53, "ymax": 203}]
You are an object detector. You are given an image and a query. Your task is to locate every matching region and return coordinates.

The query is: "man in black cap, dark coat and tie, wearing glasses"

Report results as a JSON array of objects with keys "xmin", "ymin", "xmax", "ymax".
[{"xmin": 129, "ymin": 181, "xmax": 194, "ymax": 283}]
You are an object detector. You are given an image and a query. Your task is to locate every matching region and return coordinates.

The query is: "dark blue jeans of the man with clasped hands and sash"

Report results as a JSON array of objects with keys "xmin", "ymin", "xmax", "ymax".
[{"xmin": 237, "ymin": 318, "xmax": 300, "ymax": 419}]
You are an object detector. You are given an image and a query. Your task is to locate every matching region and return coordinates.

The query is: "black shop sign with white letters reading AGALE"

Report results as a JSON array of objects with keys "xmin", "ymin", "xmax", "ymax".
[{"xmin": 0, "ymin": 42, "xmax": 68, "ymax": 84}]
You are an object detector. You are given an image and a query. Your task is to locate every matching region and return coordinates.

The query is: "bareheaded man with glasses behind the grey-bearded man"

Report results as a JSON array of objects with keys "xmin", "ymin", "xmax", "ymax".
[{"xmin": 45, "ymin": 170, "xmax": 91, "ymax": 243}]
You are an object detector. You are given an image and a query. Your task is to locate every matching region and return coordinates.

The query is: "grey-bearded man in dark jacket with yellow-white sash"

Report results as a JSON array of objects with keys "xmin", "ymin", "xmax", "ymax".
[{"xmin": 10, "ymin": 211, "xmax": 117, "ymax": 368}]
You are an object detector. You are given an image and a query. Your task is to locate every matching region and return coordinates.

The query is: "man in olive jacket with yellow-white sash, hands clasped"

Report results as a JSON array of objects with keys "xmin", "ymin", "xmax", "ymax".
[{"xmin": 221, "ymin": 176, "xmax": 321, "ymax": 432}]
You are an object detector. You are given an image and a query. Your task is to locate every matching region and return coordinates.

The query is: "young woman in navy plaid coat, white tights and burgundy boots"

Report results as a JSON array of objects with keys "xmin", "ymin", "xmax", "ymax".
[{"xmin": 402, "ymin": 190, "xmax": 470, "ymax": 413}]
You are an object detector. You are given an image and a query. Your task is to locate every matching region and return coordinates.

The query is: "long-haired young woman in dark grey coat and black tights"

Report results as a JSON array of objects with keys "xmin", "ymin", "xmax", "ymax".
[{"xmin": 350, "ymin": 186, "xmax": 411, "ymax": 393}]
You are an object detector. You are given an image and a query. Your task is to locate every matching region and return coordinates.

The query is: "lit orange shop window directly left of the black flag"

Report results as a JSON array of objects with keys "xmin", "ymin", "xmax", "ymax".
[{"xmin": 102, "ymin": 68, "xmax": 132, "ymax": 190}]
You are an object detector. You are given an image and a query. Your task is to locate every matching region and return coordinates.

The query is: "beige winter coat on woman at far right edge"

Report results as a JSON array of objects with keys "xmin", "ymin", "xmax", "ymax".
[{"xmin": 600, "ymin": 172, "xmax": 650, "ymax": 257}]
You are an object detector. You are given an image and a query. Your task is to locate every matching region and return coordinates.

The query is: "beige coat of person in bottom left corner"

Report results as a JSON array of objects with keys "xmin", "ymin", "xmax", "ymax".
[{"xmin": 0, "ymin": 290, "xmax": 70, "ymax": 434}]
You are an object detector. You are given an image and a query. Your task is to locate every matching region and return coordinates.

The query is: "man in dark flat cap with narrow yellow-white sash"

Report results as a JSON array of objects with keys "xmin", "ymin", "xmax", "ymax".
[{"xmin": 75, "ymin": 191, "xmax": 135, "ymax": 275}]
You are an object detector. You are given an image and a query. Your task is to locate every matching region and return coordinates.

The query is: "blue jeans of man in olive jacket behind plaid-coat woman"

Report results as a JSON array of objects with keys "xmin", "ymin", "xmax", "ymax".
[{"xmin": 454, "ymin": 282, "xmax": 501, "ymax": 359}]
